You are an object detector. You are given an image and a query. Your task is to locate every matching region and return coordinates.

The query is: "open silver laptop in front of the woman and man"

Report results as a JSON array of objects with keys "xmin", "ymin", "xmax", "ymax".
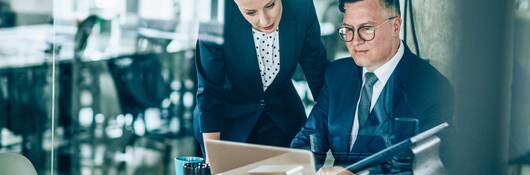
[{"xmin": 205, "ymin": 140, "xmax": 316, "ymax": 175}]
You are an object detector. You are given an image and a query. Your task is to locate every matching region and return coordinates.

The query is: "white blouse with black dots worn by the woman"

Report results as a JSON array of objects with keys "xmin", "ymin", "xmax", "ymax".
[{"xmin": 252, "ymin": 29, "xmax": 280, "ymax": 91}]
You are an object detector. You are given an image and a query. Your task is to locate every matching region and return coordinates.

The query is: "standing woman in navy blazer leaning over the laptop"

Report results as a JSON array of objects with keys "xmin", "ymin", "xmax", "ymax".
[{"xmin": 194, "ymin": 0, "xmax": 328, "ymax": 153}]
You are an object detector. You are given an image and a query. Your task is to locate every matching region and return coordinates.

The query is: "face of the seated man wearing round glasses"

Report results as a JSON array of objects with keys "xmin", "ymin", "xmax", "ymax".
[{"xmin": 343, "ymin": 0, "xmax": 401, "ymax": 71}]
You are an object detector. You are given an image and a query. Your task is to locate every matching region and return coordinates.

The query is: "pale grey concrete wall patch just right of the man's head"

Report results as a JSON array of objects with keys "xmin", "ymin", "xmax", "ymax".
[{"xmin": 402, "ymin": 0, "xmax": 461, "ymax": 78}]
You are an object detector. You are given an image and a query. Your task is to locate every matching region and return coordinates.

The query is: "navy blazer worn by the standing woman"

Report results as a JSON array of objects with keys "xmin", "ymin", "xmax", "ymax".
[{"xmin": 194, "ymin": 0, "xmax": 328, "ymax": 146}]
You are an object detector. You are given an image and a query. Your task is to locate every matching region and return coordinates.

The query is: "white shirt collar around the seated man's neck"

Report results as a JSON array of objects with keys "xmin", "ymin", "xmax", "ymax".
[{"xmin": 363, "ymin": 41, "xmax": 405, "ymax": 84}]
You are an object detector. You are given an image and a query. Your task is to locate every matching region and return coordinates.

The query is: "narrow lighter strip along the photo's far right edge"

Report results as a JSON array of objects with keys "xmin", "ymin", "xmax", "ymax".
[{"xmin": 509, "ymin": 0, "xmax": 530, "ymax": 174}]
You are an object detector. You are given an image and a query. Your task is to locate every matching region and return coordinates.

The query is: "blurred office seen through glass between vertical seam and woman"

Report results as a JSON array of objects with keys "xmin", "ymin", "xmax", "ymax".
[{"xmin": 49, "ymin": 0, "xmax": 205, "ymax": 174}]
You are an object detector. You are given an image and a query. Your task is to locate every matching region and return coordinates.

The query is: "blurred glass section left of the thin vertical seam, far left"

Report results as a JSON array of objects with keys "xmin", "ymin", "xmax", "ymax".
[{"xmin": 0, "ymin": 0, "xmax": 54, "ymax": 174}]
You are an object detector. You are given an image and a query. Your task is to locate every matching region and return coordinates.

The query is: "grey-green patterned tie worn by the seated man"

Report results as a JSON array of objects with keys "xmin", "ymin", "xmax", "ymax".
[{"xmin": 357, "ymin": 72, "xmax": 378, "ymax": 127}]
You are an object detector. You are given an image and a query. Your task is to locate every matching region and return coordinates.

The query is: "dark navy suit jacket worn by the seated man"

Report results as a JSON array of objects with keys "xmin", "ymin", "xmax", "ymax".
[{"xmin": 291, "ymin": 44, "xmax": 453, "ymax": 172}]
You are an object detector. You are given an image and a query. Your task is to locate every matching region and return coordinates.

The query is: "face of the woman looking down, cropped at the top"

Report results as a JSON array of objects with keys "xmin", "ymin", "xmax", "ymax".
[{"xmin": 234, "ymin": 0, "xmax": 282, "ymax": 33}]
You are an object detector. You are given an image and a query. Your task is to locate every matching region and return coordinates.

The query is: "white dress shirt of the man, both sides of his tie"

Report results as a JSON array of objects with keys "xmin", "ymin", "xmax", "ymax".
[{"xmin": 350, "ymin": 42, "xmax": 405, "ymax": 150}]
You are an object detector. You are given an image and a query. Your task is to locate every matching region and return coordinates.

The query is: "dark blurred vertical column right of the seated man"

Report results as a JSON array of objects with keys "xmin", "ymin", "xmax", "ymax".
[{"xmin": 452, "ymin": 0, "xmax": 514, "ymax": 175}]
